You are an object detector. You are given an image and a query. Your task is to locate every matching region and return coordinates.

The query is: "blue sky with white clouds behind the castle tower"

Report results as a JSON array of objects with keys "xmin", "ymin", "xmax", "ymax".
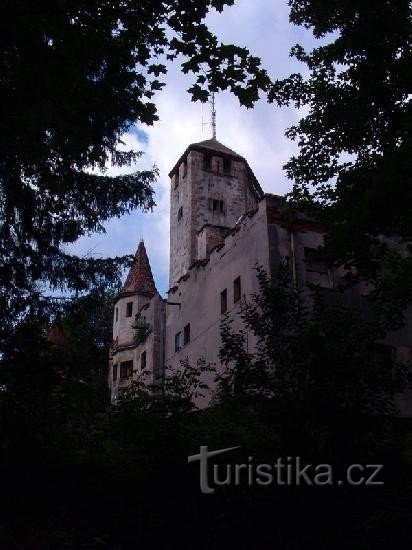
[{"xmin": 71, "ymin": 0, "xmax": 314, "ymax": 295}]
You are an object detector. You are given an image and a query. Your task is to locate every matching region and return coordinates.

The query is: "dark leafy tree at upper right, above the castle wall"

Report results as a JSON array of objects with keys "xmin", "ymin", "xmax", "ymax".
[{"xmin": 270, "ymin": 0, "xmax": 412, "ymax": 316}]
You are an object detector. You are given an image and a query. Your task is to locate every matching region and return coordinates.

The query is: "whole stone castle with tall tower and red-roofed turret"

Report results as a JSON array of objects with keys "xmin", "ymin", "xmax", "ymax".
[{"xmin": 109, "ymin": 138, "xmax": 412, "ymax": 412}]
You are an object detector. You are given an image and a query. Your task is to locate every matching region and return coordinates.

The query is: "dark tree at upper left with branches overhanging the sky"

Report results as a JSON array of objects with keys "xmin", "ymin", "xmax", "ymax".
[{"xmin": 0, "ymin": 0, "xmax": 267, "ymax": 344}]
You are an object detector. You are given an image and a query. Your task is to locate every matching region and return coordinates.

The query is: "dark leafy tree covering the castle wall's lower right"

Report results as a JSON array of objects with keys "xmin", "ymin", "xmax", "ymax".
[{"xmin": 219, "ymin": 266, "xmax": 405, "ymax": 454}]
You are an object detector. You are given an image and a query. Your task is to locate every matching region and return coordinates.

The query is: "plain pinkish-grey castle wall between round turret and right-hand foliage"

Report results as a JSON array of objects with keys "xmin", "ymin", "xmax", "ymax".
[{"xmin": 165, "ymin": 201, "xmax": 269, "ymax": 407}]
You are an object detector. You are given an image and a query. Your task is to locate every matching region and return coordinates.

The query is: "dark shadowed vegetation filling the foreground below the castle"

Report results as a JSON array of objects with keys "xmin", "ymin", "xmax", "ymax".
[{"xmin": 0, "ymin": 270, "xmax": 412, "ymax": 549}]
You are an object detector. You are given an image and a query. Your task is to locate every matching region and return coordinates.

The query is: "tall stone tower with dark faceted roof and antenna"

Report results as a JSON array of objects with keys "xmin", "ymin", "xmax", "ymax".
[{"xmin": 169, "ymin": 138, "xmax": 263, "ymax": 287}]
